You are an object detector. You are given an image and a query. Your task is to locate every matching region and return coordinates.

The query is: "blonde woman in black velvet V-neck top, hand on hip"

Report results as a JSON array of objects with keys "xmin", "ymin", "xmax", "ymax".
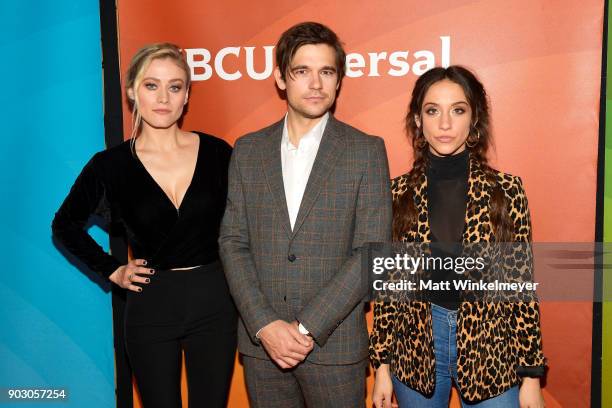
[{"xmin": 53, "ymin": 43, "xmax": 237, "ymax": 408}]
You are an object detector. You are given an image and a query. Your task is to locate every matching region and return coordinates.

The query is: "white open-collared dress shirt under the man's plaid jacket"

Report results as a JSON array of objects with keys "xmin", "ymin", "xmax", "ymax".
[{"xmin": 281, "ymin": 113, "xmax": 329, "ymax": 229}]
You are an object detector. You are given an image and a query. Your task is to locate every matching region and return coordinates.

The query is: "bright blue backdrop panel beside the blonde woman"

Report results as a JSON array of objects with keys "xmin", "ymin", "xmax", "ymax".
[{"xmin": 0, "ymin": 0, "xmax": 114, "ymax": 407}]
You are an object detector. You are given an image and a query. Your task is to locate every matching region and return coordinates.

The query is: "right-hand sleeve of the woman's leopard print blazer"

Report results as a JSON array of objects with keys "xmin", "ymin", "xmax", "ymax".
[{"xmin": 502, "ymin": 175, "xmax": 546, "ymax": 377}]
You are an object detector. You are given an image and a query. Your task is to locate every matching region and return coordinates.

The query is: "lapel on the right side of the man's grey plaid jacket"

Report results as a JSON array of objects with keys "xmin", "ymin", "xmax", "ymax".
[{"xmin": 292, "ymin": 114, "xmax": 344, "ymax": 237}]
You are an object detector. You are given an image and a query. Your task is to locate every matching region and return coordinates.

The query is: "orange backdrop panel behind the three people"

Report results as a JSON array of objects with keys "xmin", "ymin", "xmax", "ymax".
[{"xmin": 117, "ymin": 0, "xmax": 603, "ymax": 407}]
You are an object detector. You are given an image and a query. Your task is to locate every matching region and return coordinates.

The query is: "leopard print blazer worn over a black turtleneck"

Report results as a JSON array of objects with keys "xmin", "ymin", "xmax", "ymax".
[{"xmin": 369, "ymin": 159, "xmax": 545, "ymax": 402}]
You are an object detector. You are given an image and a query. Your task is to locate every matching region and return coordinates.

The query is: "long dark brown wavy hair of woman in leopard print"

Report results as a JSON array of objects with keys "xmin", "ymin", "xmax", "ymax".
[{"xmin": 393, "ymin": 65, "xmax": 513, "ymax": 242}]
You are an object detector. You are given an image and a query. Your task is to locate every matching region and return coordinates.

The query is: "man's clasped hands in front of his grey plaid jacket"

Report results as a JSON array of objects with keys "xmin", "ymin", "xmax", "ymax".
[{"xmin": 259, "ymin": 320, "xmax": 314, "ymax": 368}]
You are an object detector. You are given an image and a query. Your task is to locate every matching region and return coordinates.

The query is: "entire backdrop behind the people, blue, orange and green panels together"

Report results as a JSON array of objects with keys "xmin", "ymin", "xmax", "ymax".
[{"xmin": 0, "ymin": 0, "xmax": 612, "ymax": 408}]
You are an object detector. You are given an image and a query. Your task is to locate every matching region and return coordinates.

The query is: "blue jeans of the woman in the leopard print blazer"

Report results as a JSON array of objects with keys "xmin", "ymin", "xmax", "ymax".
[{"xmin": 393, "ymin": 303, "xmax": 519, "ymax": 408}]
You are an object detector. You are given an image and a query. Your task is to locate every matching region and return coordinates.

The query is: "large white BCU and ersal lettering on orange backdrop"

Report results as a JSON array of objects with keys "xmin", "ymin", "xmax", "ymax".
[{"xmin": 185, "ymin": 36, "xmax": 451, "ymax": 81}]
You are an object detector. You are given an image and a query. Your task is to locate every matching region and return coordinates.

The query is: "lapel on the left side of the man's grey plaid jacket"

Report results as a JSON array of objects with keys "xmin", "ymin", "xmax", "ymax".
[{"xmin": 261, "ymin": 119, "xmax": 291, "ymax": 237}]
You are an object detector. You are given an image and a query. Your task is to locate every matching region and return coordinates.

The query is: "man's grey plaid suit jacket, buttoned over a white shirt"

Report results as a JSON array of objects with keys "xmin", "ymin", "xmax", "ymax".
[{"xmin": 219, "ymin": 116, "xmax": 391, "ymax": 364}]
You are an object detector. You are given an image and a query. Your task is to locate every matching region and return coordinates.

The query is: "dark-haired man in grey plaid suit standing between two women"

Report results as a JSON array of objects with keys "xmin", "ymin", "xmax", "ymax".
[{"xmin": 219, "ymin": 23, "xmax": 391, "ymax": 408}]
